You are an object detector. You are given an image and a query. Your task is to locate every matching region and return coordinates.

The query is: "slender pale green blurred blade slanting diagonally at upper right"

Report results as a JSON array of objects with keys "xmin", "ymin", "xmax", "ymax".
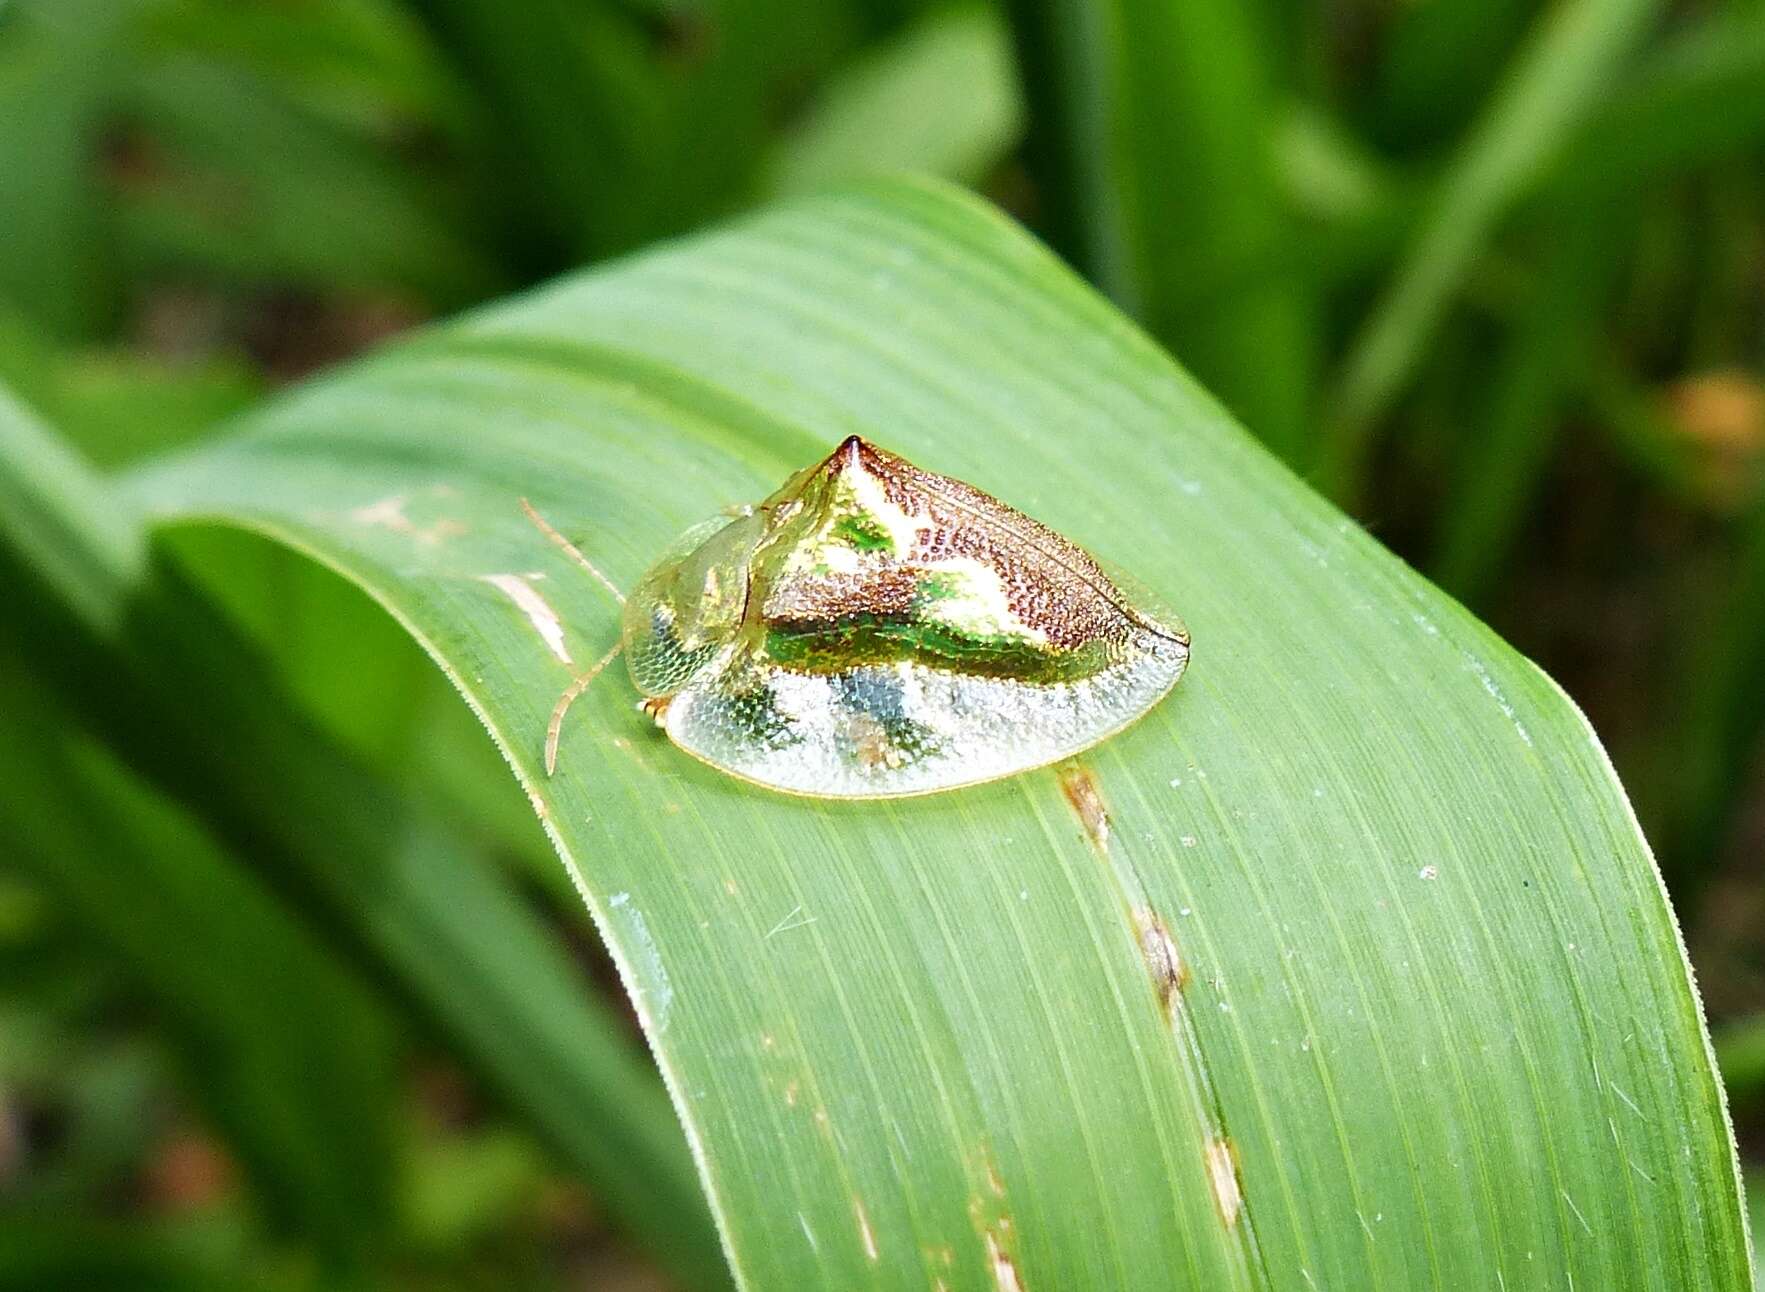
[{"xmin": 1320, "ymin": 0, "xmax": 1661, "ymax": 494}]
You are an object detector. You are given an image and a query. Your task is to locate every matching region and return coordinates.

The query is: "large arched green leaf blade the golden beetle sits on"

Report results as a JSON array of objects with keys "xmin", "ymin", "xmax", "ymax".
[{"xmin": 127, "ymin": 184, "xmax": 1747, "ymax": 1292}]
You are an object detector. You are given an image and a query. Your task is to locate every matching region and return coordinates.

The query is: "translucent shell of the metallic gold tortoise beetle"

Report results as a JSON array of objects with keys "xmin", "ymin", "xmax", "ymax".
[{"xmin": 600, "ymin": 436, "xmax": 1190, "ymax": 798}]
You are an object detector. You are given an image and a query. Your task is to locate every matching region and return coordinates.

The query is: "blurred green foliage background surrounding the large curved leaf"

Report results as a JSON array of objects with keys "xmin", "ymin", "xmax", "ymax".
[{"xmin": 0, "ymin": 0, "xmax": 1765, "ymax": 1288}]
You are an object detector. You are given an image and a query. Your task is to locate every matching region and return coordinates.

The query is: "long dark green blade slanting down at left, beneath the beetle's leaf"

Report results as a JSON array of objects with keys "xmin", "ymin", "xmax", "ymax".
[{"xmin": 0, "ymin": 394, "xmax": 724, "ymax": 1287}]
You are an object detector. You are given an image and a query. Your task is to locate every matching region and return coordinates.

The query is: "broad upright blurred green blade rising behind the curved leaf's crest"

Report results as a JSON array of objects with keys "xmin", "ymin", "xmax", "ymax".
[{"xmin": 1010, "ymin": 0, "xmax": 1317, "ymax": 461}]
